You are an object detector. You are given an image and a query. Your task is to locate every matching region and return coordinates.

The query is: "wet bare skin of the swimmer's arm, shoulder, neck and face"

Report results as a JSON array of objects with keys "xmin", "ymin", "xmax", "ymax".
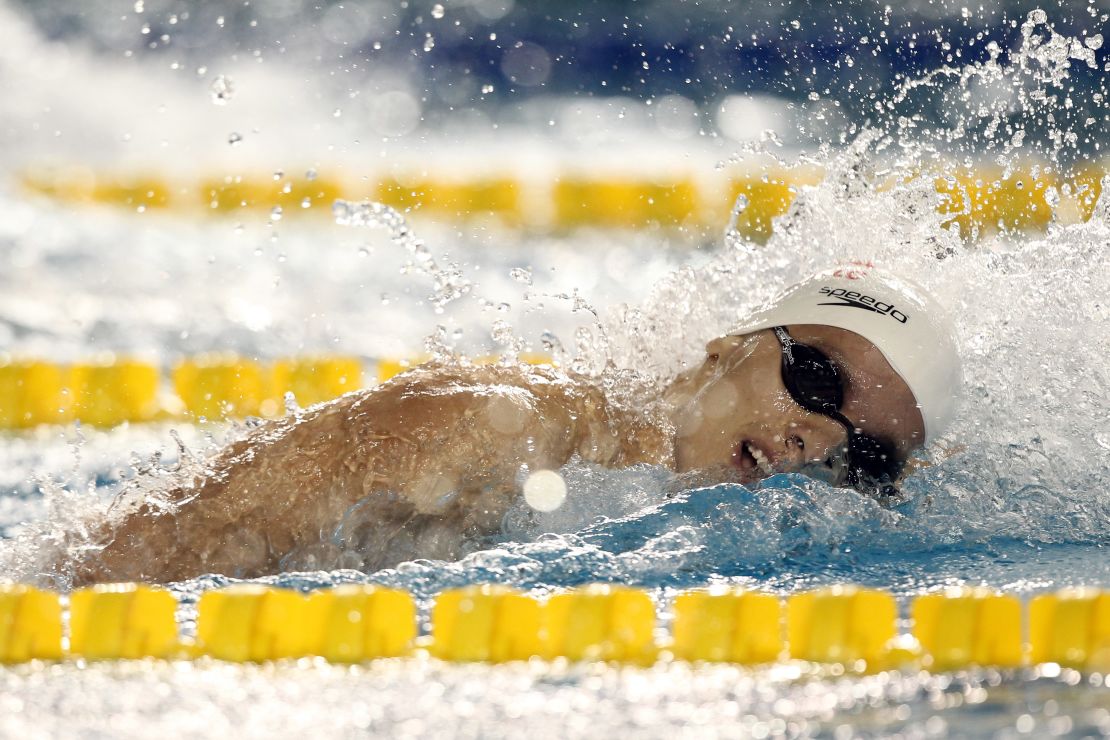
[{"xmin": 64, "ymin": 325, "xmax": 924, "ymax": 585}]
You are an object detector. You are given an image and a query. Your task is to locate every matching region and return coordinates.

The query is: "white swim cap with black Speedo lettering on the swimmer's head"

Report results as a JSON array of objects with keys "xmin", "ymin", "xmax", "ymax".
[{"xmin": 730, "ymin": 263, "xmax": 960, "ymax": 442}]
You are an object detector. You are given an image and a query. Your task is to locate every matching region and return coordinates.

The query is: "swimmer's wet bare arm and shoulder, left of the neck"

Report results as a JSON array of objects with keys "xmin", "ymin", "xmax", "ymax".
[{"xmin": 75, "ymin": 363, "xmax": 578, "ymax": 582}]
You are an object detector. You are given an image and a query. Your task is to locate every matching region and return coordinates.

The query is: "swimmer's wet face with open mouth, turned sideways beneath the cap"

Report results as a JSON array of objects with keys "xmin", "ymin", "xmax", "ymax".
[{"xmin": 666, "ymin": 324, "xmax": 925, "ymax": 484}]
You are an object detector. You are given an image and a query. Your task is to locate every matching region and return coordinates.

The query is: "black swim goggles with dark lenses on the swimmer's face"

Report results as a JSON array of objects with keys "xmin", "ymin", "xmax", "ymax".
[{"xmin": 773, "ymin": 326, "xmax": 902, "ymax": 497}]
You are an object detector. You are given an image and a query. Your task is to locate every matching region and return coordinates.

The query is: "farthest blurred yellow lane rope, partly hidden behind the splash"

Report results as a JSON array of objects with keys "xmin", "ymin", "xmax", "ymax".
[{"xmin": 19, "ymin": 163, "xmax": 1106, "ymax": 240}]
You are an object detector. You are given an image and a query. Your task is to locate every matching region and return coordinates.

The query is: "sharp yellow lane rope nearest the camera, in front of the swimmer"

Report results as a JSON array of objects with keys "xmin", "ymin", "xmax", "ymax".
[{"xmin": 0, "ymin": 584, "xmax": 1110, "ymax": 675}]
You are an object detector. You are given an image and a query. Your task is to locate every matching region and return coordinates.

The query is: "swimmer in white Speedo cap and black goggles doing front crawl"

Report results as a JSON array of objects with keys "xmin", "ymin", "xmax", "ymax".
[{"xmin": 69, "ymin": 265, "xmax": 959, "ymax": 586}]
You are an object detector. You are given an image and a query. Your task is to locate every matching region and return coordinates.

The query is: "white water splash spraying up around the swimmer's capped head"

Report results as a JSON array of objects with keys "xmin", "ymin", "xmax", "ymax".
[{"xmin": 526, "ymin": 13, "xmax": 1110, "ymax": 576}]
